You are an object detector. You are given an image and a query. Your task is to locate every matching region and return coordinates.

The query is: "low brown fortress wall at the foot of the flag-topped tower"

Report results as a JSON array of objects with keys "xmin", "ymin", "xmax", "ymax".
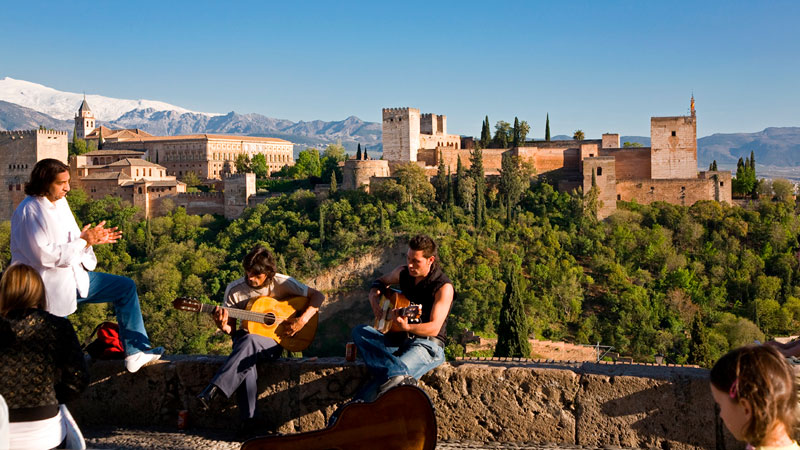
[{"xmin": 617, "ymin": 178, "xmax": 730, "ymax": 206}]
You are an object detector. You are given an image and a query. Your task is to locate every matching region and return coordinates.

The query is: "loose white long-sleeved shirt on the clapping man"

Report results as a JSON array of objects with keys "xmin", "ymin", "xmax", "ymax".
[{"xmin": 11, "ymin": 196, "xmax": 97, "ymax": 317}]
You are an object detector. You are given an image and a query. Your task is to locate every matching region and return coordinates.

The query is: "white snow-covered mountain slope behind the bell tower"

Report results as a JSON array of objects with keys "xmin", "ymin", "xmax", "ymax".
[{"xmin": 0, "ymin": 77, "xmax": 217, "ymax": 121}]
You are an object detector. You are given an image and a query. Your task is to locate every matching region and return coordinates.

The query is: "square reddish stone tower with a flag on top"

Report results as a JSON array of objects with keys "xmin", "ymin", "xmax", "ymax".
[{"xmin": 650, "ymin": 97, "xmax": 697, "ymax": 179}]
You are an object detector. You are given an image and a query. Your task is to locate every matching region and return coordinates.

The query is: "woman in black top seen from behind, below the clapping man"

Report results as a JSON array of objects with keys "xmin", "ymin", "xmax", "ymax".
[{"xmin": 0, "ymin": 264, "xmax": 89, "ymax": 449}]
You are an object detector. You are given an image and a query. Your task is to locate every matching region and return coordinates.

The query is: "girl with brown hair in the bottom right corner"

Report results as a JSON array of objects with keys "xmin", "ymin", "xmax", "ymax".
[{"xmin": 710, "ymin": 345, "xmax": 800, "ymax": 450}]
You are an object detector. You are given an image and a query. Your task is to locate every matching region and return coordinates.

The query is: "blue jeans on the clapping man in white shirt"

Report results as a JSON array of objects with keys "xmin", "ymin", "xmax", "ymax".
[{"xmin": 78, "ymin": 272, "xmax": 150, "ymax": 355}]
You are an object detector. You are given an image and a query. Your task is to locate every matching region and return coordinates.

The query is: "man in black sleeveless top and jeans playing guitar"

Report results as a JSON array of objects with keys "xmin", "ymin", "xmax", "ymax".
[{"xmin": 352, "ymin": 235, "xmax": 455, "ymax": 401}]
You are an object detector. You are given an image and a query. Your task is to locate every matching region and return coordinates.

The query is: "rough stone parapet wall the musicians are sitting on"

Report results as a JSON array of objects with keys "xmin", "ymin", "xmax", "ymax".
[{"xmin": 68, "ymin": 356, "xmax": 732, "ymax": 449}]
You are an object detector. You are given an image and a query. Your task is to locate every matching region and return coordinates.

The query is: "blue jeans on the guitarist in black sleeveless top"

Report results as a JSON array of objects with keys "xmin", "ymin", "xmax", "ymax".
[{"xmin": 352, "ymin": 325, "xmax": 444, "ymax": 398}]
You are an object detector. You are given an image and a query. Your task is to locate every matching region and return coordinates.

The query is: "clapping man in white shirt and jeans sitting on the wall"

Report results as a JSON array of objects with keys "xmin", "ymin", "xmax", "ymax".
[{"xmin": 11, "ymin": 159, "xmax": 164, "ymax": 372}]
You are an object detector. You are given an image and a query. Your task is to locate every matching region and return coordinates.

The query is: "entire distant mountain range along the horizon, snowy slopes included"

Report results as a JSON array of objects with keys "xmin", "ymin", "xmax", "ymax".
[{"xmin": 0, "ymin": 77, "xmax": 800, "ymax": 169}]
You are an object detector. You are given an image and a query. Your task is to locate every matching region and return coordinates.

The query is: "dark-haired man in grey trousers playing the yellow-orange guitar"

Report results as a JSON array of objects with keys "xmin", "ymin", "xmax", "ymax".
[{"xmin": 197, "ymin": 245, "xmax": 325, "ymax": 437}]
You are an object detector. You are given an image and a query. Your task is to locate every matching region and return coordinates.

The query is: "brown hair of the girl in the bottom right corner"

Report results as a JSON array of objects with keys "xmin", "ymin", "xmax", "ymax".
[{"xmin": 710, "ymin": 345, "xmax": 797, "ymax": 446}]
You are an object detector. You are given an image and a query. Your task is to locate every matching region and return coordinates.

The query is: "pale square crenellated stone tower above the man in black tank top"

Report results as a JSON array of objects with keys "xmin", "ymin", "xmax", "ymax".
[{"xmin": 383, "ymin": 108, "xmax": 420, "ymax": 161}]
